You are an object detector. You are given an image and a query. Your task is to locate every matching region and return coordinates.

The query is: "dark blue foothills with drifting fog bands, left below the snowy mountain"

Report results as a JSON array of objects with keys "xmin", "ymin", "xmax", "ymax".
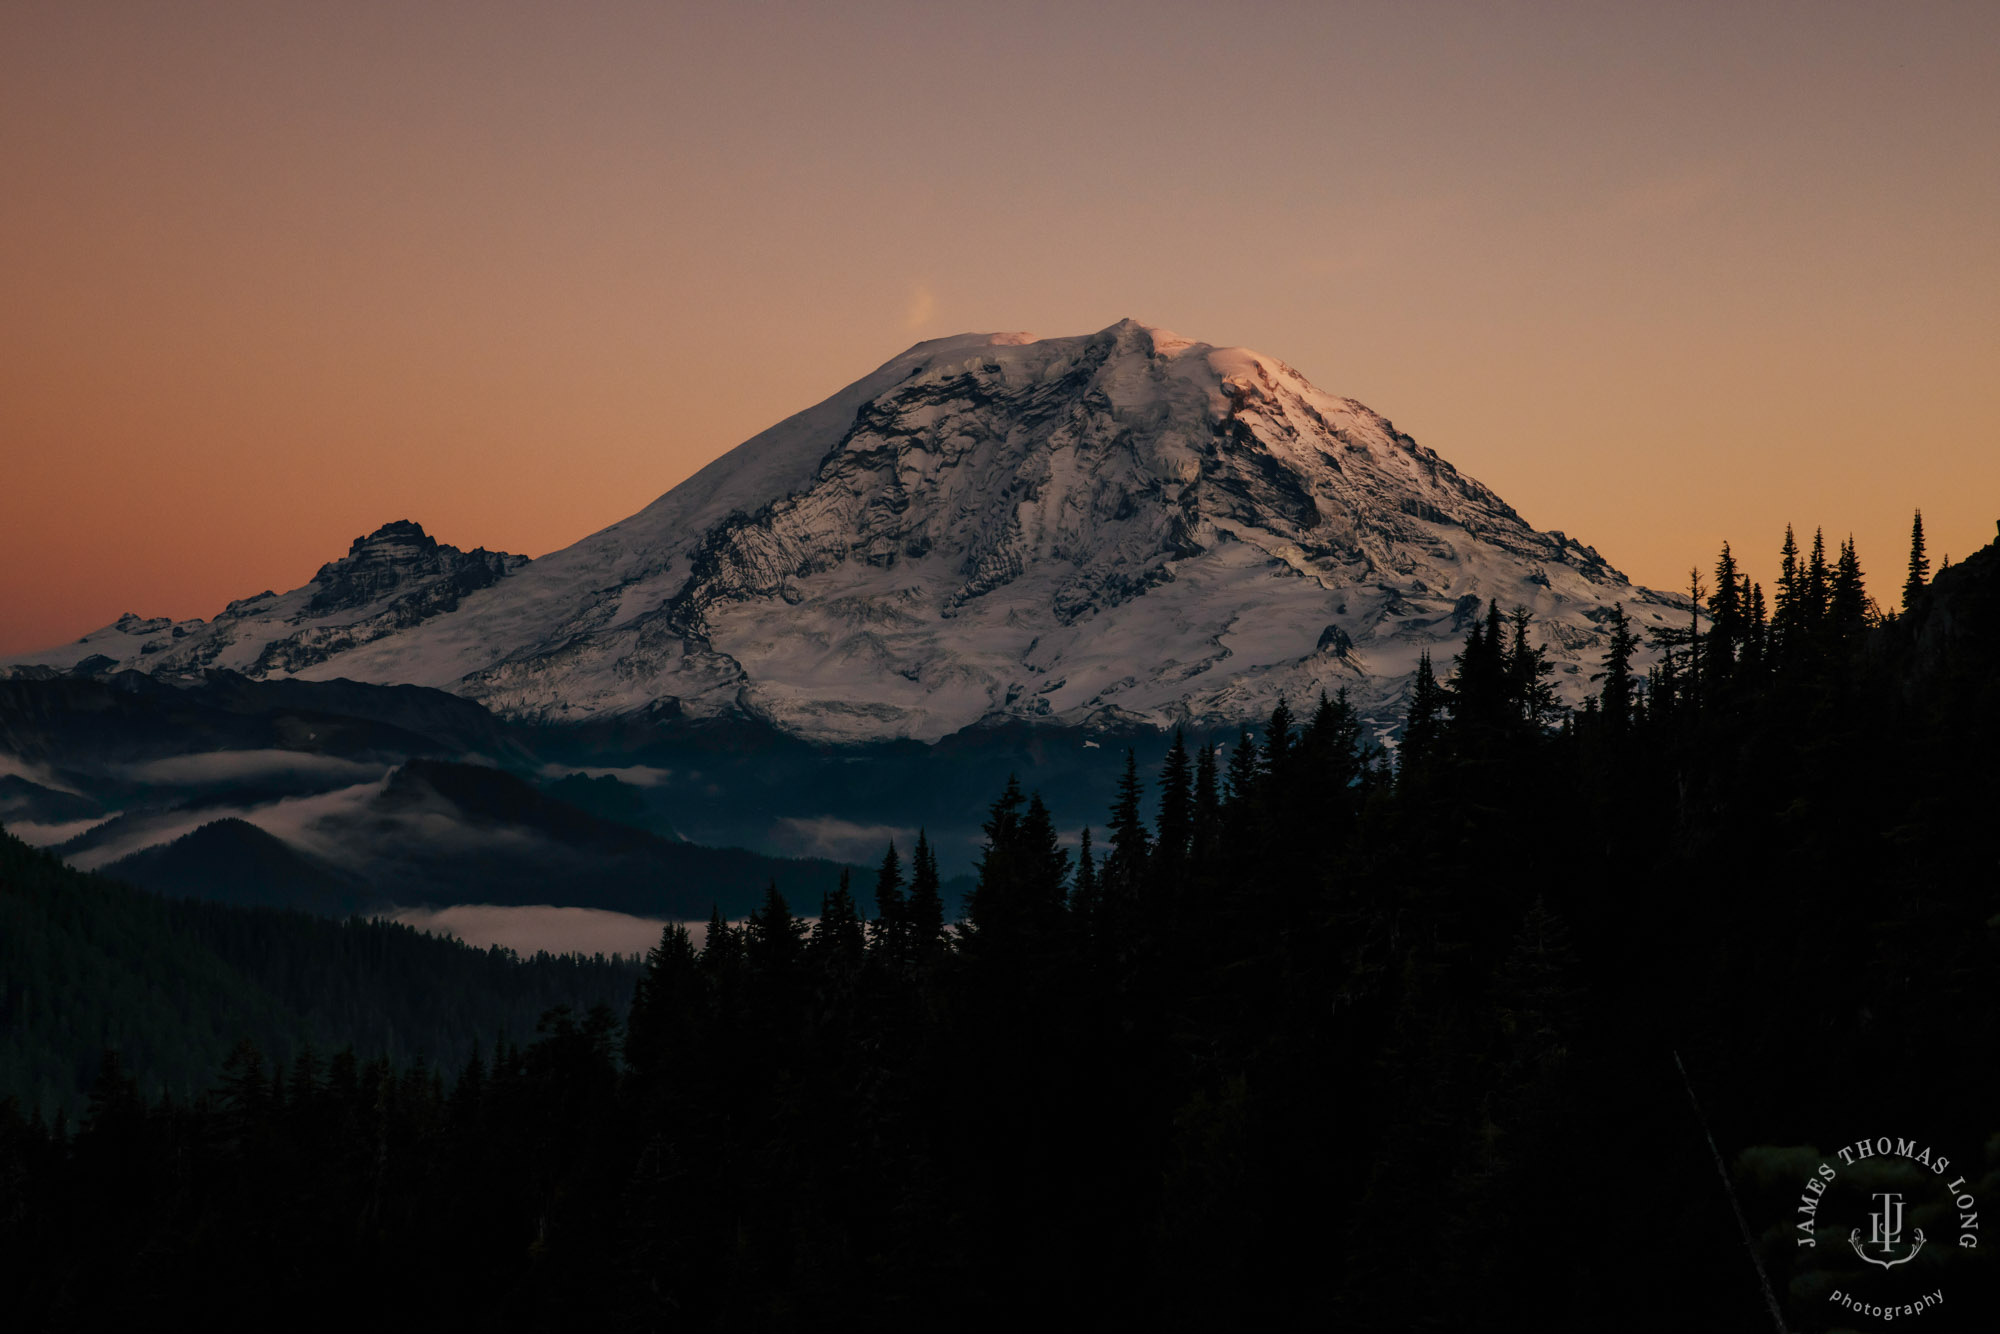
[{"xmin": 0, "ymin": 670, "xmax": 886, "ymax": 920}]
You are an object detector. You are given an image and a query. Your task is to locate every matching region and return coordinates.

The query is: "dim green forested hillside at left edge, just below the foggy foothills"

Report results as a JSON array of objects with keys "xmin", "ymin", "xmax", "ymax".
[{"xmin": 0, "ymin": 832, "xmax": 636, "ymax": 1116}]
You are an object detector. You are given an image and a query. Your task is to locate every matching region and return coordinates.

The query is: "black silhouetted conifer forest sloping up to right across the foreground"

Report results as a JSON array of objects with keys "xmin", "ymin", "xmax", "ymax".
[{"xmin": 0, "ymin": 540, "xmax": 2000, "ymax": 1330}]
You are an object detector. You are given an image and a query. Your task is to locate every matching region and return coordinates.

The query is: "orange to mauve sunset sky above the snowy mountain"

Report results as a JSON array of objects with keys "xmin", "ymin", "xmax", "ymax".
[{"xmin": 0, "ymin": 0, "xmax": 2000, "ymax": 652}]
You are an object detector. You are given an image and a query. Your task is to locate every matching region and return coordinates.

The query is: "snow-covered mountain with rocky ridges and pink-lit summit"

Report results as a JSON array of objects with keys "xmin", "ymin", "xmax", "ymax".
[{"xmin": 16, "ymin": 320, "xmax": 1684, "ymax": 740}]
